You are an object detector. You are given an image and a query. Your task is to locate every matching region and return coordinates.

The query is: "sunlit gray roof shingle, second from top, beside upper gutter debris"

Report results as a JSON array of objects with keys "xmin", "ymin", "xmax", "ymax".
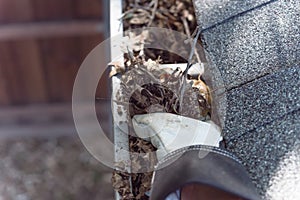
[{"xmin": 195, "ymin": 0, "xmax": 300, "ymax": 89}]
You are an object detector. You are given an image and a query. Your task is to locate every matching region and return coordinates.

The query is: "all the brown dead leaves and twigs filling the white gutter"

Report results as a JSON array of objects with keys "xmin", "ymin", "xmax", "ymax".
[{"xmin": 110, "ymin": 0, "xmax": 207, "ymax": 200}]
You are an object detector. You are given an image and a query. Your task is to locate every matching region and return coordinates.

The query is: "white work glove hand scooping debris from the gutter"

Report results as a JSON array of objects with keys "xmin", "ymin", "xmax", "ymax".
[{"xmin": 132, "ymin": 113, "xmax": 222, "ymax": 160}]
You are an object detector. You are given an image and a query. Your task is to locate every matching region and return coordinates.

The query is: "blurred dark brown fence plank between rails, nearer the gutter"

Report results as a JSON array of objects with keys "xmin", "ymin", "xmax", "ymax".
[{"xmin": 41, "ymin": 37, "xmax": 83, "ymax": 102}]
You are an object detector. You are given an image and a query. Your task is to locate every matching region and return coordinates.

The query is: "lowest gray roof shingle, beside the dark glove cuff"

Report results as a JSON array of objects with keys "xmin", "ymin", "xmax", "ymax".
[{"xmin": 228, "ymin": 110, "xmax": 300, "ymax": 195}]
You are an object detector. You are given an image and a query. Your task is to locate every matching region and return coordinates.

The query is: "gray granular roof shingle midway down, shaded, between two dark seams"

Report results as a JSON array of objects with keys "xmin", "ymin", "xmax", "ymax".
[{"xmin": 224, "ymin": 66, "xmax": 300, "ymax": 138}]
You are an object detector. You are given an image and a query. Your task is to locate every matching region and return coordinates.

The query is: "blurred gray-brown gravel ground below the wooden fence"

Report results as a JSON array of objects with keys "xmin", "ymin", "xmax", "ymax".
[{"xmin": 0, "ymin": 137, "xmax": 114, "ymax": 200}]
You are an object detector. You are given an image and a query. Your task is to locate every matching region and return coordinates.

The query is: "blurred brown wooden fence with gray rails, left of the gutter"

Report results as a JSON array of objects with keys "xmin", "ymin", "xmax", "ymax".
[{"xmin": 0, "ymin": 0, "xmax": 109, "ymax": 137}]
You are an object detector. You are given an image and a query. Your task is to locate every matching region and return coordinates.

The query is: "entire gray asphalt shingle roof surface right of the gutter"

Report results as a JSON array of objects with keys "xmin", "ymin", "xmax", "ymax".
[{"xmin": 194, "ymin": 0, "xmax": 300, "ymax": 200}]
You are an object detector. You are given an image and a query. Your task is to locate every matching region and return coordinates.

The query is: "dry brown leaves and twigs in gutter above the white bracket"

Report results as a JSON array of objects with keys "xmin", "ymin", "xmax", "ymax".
[{"xmin": 121, "ymin": 0, "xmax": 197, "ymax": 63}]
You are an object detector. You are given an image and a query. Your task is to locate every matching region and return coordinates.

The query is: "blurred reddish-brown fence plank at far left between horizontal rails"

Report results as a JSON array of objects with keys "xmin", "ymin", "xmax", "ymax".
[{"xmin": 2, "ymin": 0, "xmax": 47, "ymax": 104}]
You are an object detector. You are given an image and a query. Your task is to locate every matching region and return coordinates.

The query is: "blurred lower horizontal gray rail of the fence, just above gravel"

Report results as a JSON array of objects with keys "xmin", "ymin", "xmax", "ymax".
[{"xmin": 0, "ymin": 103, "xmax": 108, "ymax": 138}]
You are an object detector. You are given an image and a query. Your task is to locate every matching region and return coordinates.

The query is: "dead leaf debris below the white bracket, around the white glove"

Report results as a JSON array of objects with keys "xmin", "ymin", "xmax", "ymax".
[{"xmin": 113, "ymin": 56, "xmax": 210, "ymax": 199}]
